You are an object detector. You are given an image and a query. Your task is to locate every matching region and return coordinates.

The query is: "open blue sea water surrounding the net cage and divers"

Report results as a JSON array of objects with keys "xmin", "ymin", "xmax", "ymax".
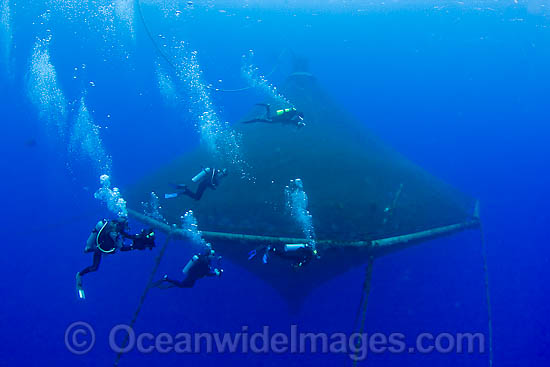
[{"xmin": 0, "ymin": 1, "xmax": 550, "ymax": 366}]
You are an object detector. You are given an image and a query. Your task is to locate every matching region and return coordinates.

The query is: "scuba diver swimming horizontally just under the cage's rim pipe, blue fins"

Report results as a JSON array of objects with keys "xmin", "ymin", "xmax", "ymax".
[{"xmin": 248, "ymin": 243, "xmax": 319, "ymax": 269}]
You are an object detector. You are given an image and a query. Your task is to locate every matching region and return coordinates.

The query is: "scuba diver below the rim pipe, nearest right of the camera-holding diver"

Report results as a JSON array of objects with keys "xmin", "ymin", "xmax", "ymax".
[{"xmin": 151, "ymin": 246, "xmax": 223, "ymax": 289}]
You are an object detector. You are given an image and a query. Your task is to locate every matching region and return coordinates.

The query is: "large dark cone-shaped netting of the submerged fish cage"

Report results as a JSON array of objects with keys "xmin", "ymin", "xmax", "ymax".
[{"xmin": 125, "ymin": 73, "xmax": 473, "ymax": 306}]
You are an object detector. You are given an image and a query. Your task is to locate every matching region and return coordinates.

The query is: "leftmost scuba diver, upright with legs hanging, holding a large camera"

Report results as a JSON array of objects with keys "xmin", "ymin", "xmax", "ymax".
[{"xmin": 76, "ymin": 218, "xmax": 155, "ymax": 299}]
